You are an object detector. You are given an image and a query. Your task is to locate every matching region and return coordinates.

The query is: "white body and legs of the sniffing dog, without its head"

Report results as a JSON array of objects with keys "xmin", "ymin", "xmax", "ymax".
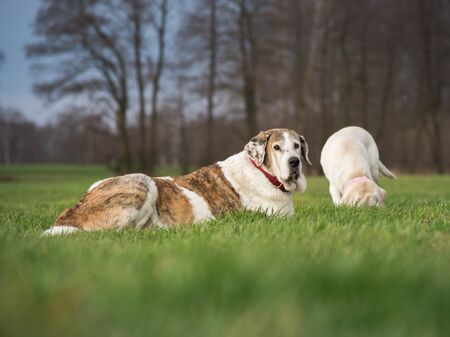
[{"xmin": 320, "ymin": 126, "xmax": 394, "ymax": 205}]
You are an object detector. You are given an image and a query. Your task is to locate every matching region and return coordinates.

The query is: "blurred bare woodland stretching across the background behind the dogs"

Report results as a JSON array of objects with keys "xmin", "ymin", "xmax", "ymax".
[{"xmin": 0, "ymin": 0, "xmax": 450, "ymax": 173}]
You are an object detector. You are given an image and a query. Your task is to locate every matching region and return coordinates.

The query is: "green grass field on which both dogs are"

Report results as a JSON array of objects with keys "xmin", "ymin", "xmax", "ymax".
[{"xmin": 0, "ymin": 166, "xmax": 450, "ymax": 337}]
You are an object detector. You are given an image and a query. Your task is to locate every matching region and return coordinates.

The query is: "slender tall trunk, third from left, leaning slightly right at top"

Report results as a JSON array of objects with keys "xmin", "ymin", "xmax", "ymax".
[{"xmin": 149, "ymin": 0, "xmax": 167, "ymax": 173}]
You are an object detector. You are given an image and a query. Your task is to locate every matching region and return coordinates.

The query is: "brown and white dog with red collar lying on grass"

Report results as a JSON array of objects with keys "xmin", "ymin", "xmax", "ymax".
[{"xmin": 44, "ymin": 129, "xmax": 310, "ymax": 235}]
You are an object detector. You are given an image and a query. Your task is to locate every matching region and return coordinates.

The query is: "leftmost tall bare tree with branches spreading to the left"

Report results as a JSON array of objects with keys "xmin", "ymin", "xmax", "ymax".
[{"xmin": 27, "ymin": 0, "xmax": 132, "ymax": 171}]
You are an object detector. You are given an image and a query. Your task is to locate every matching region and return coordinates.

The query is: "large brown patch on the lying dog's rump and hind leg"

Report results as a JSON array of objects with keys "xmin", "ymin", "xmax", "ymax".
[{"xmin": 54, "ymin": 174, "xmax": 148, "ymax": 230}]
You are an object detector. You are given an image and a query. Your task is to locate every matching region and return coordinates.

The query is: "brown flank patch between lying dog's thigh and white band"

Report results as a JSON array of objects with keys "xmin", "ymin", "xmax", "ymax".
[{"xmin": 153, "ymin": 178, "xmax": 194, "ymax": 225}]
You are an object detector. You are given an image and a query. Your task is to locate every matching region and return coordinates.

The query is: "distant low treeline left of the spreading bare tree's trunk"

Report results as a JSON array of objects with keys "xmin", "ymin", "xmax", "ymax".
[{"xmin": 0, "ymin": 106, "xmax": 114, "ymax": 165}]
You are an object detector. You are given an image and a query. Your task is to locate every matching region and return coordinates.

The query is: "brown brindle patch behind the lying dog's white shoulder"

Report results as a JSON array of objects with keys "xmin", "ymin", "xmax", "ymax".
[{"xmin": 173, "ymin": 164, "xmax": 242, "ymax": 216}]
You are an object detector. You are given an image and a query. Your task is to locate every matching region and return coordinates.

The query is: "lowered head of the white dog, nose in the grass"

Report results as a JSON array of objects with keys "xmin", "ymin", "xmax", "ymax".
[{"xmin": 340, "ymin": 180, "xmax": 386, "ymax": 206}]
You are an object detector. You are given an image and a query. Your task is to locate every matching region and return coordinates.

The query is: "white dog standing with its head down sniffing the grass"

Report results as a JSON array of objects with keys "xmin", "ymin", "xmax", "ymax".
[{"xmin": 320, "ymin": 126, "xmax": 396, "ymax": 206}]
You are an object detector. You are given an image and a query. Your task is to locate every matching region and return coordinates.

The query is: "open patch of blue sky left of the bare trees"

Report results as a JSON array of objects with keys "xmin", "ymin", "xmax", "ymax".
[{"xmin": 0, "ymin": 0, "xmax": 53, "ymax": 124}]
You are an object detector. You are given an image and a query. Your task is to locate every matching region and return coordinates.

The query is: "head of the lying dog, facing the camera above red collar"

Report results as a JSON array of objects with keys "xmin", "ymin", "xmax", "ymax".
[{"xmin": 245, "ymin": 129, "xmax": 311, "ymax": 192}]
